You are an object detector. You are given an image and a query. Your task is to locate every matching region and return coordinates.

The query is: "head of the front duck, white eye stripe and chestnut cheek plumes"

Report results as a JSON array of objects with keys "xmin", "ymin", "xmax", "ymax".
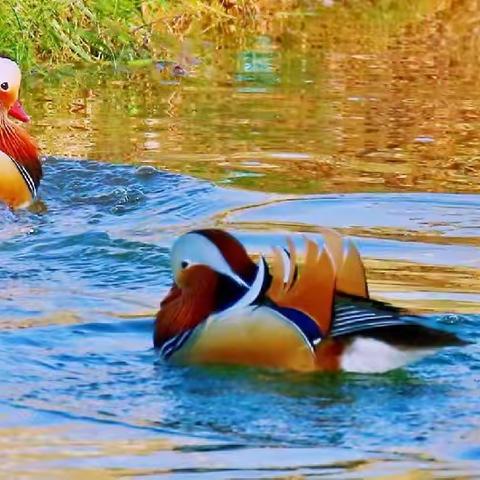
[{"xmin": 154, "ymin": 229, "xmax": 269, "ymax": 346}]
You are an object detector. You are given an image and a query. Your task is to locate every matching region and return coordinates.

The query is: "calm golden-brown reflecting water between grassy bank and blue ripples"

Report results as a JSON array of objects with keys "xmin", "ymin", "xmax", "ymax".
[{"xmin": 24, "ymin": 1, "xmax": 480, "ymax": 193}]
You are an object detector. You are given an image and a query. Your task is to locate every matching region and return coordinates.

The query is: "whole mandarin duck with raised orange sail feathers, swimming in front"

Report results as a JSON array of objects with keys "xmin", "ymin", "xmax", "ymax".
[{"xmin": 154, "ymin": 229, "xmax": 465, "ymax": 373}]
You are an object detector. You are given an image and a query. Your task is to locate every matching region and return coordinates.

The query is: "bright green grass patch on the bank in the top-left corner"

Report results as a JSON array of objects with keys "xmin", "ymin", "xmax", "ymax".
[{"xmin": 0, "ymin": 0, "xmax": 157, "ymax": 65}]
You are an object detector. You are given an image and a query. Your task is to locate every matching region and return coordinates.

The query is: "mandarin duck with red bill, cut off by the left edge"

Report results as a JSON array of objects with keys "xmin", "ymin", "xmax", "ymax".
[{"xmin": 0, "ymin": 58, "xmax": 42, "ymax": 208}]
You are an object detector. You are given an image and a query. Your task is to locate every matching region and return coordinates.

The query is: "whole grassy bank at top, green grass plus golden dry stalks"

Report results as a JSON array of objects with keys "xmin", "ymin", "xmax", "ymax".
[{"xmin": 0, "ymin": 0, "xmax": 284, "ymax": 66}]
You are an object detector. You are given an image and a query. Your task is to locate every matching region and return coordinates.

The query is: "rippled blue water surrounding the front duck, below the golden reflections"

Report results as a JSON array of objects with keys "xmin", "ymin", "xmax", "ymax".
[{"xmin": 0, "ymin": 158, "xmax": 480, "ymax": 479}]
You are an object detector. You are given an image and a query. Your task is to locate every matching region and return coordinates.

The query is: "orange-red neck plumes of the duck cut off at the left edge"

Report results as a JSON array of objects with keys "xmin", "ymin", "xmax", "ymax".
[{"xmin": 0, "ymin": 111, "xmax": 43, "ymax": 187}]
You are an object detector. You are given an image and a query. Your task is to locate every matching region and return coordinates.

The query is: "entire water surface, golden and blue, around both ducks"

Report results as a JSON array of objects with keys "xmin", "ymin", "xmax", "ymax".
[{"xmin": 0, "ymin": 2, "xmax": 480, "ymax": 479}]
